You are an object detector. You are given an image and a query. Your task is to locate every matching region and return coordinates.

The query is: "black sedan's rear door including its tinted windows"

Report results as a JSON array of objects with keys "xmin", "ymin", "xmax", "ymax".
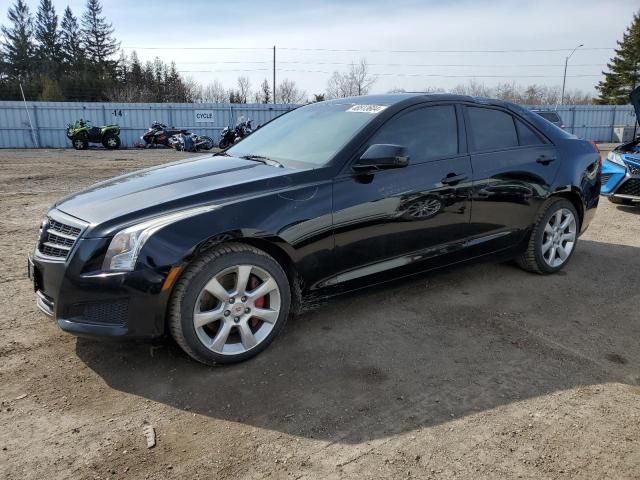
[{"xmin": 465, "ymin": 105, "xmax": 558, "ymax": 251}]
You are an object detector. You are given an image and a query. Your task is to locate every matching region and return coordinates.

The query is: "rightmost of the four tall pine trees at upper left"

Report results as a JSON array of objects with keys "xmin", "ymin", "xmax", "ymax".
[{"xmin": 82, "ymin": 0, "xmax": 119, "ymax": 76}]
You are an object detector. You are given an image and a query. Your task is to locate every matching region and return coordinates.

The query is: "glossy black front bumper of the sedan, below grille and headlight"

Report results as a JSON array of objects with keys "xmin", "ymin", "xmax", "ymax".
[{"xmin": 31, "ymin": 239, "xmax": 170, "ymax": 338}]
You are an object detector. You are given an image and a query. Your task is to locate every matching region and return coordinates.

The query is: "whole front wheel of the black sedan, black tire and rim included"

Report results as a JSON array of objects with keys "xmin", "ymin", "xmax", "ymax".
[{"xmin": 168, "ymin": 243, "xmax": 291, "ymax": 365}]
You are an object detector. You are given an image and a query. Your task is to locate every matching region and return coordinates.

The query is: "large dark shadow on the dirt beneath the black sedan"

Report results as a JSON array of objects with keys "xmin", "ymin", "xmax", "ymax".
[{"xmin": 76, "ymin": 241, "xmax": 640, "ymax": 443}]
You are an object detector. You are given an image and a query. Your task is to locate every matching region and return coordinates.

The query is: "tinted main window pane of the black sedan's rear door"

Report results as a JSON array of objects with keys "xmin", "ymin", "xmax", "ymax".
[{"xmin": 467, "ymin": 107, "xmax": 518, "ymax": 151}]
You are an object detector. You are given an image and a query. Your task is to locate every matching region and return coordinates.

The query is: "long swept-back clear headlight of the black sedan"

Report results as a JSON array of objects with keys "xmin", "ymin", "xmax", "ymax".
[{"xmin": 102, "ymin": 205, "xmax": 219, "ymax": 271}]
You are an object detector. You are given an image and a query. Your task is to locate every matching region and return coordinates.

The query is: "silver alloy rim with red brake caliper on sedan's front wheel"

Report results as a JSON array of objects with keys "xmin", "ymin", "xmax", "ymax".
[{"xmin": 193, "ymin": 265, "xmax": 281, "ymax": 355}]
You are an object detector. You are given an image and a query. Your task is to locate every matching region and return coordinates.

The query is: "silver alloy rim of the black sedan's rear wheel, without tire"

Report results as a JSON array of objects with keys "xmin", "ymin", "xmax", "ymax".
[{"xmin": 541, "ymin": 208, "xmax": 577, "ymax": 268}]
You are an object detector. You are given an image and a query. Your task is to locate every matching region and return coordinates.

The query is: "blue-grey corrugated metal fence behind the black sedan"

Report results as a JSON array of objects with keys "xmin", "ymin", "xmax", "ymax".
[{"xmin": 0, "ymin": 102, "xmax": 635, "ymax": 148}]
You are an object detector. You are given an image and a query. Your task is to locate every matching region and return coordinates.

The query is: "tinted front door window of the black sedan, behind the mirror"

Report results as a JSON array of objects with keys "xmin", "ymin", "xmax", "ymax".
[{"xmin": 369, "ymin": 105, "xmax": 458, "ymax": 163}]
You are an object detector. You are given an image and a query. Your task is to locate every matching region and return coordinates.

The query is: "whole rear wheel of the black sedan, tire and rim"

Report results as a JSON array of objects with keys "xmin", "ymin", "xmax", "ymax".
[{"xmin": 516, "ymin": 198, "xmax": 580, "ymax": 274}]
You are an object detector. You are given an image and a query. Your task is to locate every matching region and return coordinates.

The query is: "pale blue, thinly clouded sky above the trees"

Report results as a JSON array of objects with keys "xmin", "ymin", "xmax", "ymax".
[{"xmin": 0, "ymin": 0, "xmax": 640, "ymax": 95}]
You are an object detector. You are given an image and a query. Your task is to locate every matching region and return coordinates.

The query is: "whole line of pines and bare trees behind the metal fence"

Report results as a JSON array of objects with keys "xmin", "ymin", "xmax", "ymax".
[{"xmin": 0, "ymin": 0, "xmax": 640, "ymax": 105}]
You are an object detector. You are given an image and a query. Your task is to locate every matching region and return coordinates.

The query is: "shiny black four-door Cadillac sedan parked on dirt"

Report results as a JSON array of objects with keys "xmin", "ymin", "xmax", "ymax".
[{"xmin": 29, "ymin": 95, "xmax": 600, "ymax": 364}]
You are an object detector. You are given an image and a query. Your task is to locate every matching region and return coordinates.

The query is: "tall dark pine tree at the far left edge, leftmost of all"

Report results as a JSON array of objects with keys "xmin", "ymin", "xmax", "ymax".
[{"xmin": 2, "ymin": 0, "xmax": 34, "ymax": 80}]
